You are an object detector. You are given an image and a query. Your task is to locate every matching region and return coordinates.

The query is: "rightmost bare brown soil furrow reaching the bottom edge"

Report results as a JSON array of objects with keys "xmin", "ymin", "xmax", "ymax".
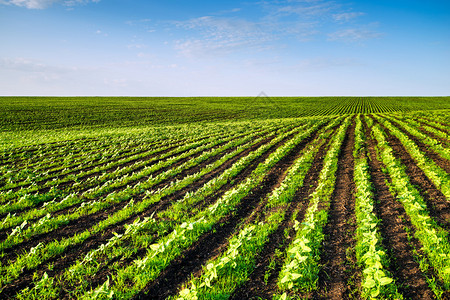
[{"xmin": 364, "ymin": 116, "xmax": 434, "ymax": 299}]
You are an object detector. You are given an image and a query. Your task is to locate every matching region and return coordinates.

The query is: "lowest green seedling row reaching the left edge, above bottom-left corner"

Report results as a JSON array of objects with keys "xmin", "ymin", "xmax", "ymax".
[{"xmin": 0, "ymin": 118, "xmax": 320, "ymax": 292}]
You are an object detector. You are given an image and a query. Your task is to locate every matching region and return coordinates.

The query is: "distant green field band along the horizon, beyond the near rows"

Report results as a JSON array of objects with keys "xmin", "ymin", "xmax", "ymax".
[{"xmin": 0, "ymin": 97, "xmax": 450, "ymax": 131}]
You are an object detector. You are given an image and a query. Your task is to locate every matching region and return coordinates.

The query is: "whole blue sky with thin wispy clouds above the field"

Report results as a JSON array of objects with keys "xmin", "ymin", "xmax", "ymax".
[{"xmin": 0, "ymin": 0, "xmax": 450, "ymax": 96}]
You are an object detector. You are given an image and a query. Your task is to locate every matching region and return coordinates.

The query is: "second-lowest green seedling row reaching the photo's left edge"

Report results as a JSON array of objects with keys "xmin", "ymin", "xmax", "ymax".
[{"xmin": 0, "ymin": 124, "xmax": 284, "ymax": 252}]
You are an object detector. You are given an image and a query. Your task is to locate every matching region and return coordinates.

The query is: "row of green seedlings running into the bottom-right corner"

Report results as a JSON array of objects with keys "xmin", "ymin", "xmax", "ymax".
[{"xmin": 372, "ymin": 118, "xmax": 450, "ymax": 289}]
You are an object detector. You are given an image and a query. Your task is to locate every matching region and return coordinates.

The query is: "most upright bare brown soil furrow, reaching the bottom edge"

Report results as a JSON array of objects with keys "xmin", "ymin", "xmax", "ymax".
[{"xmin": 316, "ymin": 121, "xmax": 356, "ymax": 299}]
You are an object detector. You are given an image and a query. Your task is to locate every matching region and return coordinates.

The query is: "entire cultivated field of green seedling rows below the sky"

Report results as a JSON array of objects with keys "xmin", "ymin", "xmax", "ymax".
[{"xmin": 0, "ymin": 97, "xmax": 450, "ymax": 299}]
